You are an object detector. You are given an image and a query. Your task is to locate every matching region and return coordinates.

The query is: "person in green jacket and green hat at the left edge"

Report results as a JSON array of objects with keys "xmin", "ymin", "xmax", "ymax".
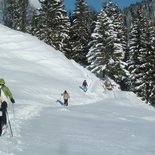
[{"xmin": 0, "ymin": 79, "xmax": 15, "ymax": 136}]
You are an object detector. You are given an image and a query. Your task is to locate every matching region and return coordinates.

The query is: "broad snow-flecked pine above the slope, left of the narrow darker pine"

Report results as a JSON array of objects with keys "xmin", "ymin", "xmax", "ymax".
[{"xmin": 32, "ymin": 0, "xmax": 70, "ymax": 51}]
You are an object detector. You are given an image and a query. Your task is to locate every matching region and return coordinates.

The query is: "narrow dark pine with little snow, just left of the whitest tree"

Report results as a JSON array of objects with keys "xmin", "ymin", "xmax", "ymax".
[{"xmin": 71, "ymin": 0, "xmax": 93, "ymax": 64}]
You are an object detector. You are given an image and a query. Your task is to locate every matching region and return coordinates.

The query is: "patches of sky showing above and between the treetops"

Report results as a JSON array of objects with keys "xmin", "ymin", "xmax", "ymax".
[{"xmin": 31, "ymin": 0, "xmax": 142, "ymax": 11}]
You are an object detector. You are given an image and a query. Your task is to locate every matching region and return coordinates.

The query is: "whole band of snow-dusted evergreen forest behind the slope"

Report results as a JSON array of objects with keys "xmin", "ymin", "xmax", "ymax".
[{"xmin": 3, "ymin": 0, "xmax": 155, "ymax": 105}]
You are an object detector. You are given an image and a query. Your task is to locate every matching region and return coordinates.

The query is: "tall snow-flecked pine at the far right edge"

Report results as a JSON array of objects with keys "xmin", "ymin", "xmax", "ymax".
[{"xmin": 129, "ymin": 11, "xmax": 155, "ymax": 102}]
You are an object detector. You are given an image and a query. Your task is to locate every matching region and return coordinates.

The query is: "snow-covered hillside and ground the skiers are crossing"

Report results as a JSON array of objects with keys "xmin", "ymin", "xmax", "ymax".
[{"xmin": 0, "ymin": 25, "xmax": 155, "ymax": 155}]
